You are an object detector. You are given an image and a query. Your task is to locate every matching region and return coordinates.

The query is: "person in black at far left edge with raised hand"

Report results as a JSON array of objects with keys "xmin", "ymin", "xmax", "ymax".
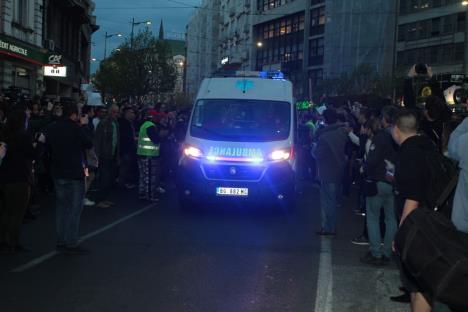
[{"xmin": 0, "ymin": 108, "xmax": 45, "ymax": 254}]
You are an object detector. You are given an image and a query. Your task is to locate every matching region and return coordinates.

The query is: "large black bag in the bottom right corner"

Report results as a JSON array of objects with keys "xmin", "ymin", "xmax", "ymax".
[{"xmin": 395, "ymin": 208, "xmax": 468, "ymax": 312}]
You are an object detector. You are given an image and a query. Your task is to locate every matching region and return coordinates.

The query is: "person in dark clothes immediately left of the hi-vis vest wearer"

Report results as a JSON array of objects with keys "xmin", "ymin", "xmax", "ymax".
[{"xmin": 119, "ymin": 107, "xmax": 137, "ymax": 189}]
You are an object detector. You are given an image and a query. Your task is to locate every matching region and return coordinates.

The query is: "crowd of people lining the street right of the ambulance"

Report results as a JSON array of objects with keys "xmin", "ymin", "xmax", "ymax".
[{"xmin": 299, "ymin": 96, "xmax": 468, "ymax": 311}]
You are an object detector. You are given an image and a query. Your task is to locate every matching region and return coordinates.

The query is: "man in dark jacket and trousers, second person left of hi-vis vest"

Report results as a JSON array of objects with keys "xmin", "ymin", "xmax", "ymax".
[{"xmin": 94, "ymin": 105, "xmax": 120, "ymax": 208}]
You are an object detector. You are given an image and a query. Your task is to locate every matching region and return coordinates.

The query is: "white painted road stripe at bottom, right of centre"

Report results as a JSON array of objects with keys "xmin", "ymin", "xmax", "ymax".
[{"xmin": 314, "ymin": 237, "xmax": 333, "ymax": 312}]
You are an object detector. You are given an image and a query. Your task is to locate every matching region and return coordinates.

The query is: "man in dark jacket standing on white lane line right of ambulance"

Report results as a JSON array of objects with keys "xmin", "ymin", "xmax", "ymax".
[{"xmin": 314, "ymin": 109, "xmax": 348, "ymax": 235}]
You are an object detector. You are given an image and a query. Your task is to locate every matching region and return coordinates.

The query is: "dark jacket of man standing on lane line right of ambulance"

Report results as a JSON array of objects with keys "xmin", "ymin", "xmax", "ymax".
[{"xmin": 314, "ymin": 125, "xmax": 348, "ymax": 183}]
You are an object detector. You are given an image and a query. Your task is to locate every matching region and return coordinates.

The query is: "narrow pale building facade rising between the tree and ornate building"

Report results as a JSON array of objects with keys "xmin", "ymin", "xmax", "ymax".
[{"xmin": 185, "ymin": 0, "xmax": 221, "ymax": 96}]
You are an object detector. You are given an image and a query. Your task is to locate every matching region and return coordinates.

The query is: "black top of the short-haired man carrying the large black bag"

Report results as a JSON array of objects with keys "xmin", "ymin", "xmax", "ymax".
[{"xmin": 395, "ymin": 135, "xmax": 437, "ymax": 203}]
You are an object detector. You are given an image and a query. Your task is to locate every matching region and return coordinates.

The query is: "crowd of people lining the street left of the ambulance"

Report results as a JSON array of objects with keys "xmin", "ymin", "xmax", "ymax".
[{"xmin": 0, "ymin": 95, "xmax": 188, "ymax": 254}]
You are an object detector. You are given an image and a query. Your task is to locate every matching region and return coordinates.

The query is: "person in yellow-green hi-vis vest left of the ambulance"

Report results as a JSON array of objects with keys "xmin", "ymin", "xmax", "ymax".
[{"xmin": 137, "ymin": 109, "xmax": 168, "ymax": 202}]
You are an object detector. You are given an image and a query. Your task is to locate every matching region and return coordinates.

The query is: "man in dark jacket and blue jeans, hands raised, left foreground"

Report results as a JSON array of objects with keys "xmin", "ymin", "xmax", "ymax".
[{"xmin": 46, "ymin": 103, "xmax": 93, "ymax": 254}]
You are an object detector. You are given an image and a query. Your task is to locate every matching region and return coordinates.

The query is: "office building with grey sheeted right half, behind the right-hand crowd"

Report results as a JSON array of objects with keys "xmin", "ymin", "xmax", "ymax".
[{"xmin": 254, "ymin": 0, "xmax": 397, "ymax": 99}]
